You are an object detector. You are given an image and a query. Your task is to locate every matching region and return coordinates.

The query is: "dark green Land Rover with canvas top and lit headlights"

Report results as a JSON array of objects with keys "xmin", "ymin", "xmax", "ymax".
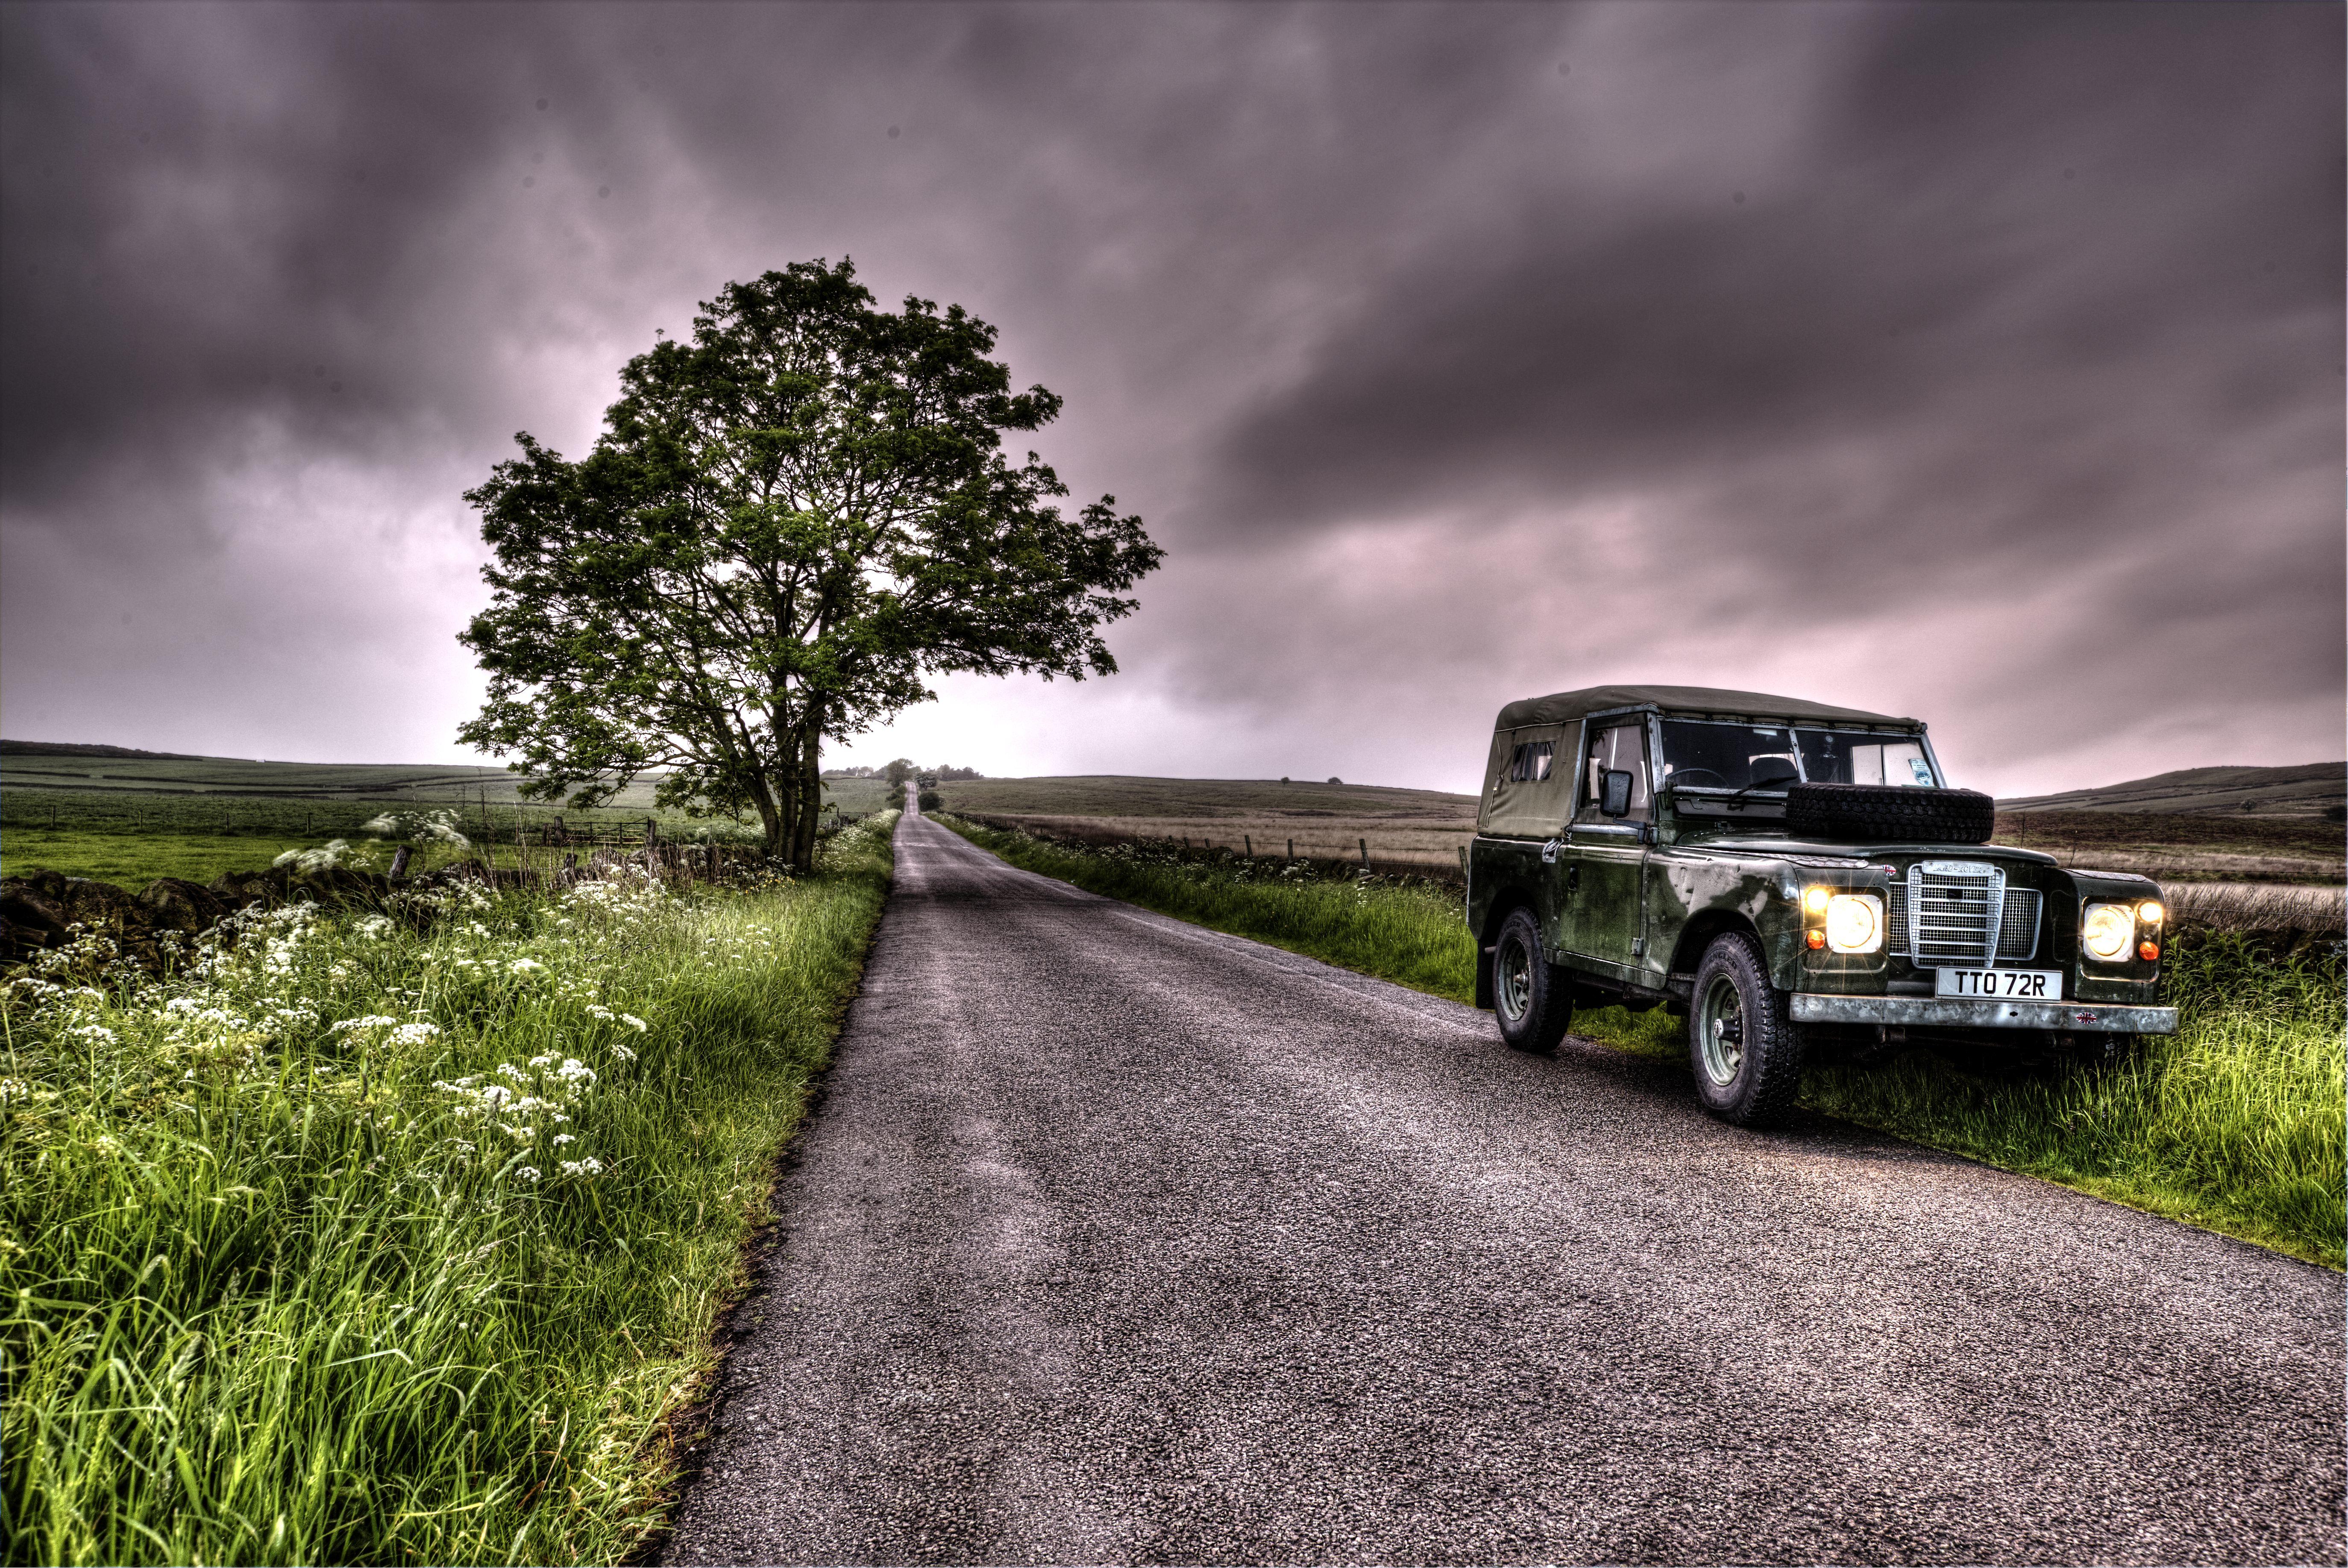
[{"xmin": 1468, "ymin": 685, "xmax": 2177, "ymax": 1125}]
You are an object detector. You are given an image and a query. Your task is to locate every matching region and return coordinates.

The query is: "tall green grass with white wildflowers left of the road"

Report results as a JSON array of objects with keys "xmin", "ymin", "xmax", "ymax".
[{"xmin": 0, "ymin": 819, "xmax": 890, "ymax": 1563}]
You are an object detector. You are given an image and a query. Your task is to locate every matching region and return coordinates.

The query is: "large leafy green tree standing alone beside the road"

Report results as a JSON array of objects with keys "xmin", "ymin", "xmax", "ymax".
[{"xmin": 458, "ymin": 261, "xmax": 1162, "ymax": 869}]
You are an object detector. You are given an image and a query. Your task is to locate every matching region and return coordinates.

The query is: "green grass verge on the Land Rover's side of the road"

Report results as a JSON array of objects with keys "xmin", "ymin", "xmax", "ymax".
[{"xmin": 942, "ymin": 819, "xmax": 2348, "ymax": 1268}]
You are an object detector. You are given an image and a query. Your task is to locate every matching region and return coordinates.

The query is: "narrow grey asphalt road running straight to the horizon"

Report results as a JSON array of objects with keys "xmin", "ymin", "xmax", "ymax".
[{"xmin": 667, "ymin": 817, "xmax": 2348, "ymax": 1563}]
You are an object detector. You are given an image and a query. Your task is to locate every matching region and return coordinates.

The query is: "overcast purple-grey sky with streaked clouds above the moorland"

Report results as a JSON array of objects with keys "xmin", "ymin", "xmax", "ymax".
[{"xmin": 0, "ymin": 0, "xmax": 2348, "ymax": 793}]
